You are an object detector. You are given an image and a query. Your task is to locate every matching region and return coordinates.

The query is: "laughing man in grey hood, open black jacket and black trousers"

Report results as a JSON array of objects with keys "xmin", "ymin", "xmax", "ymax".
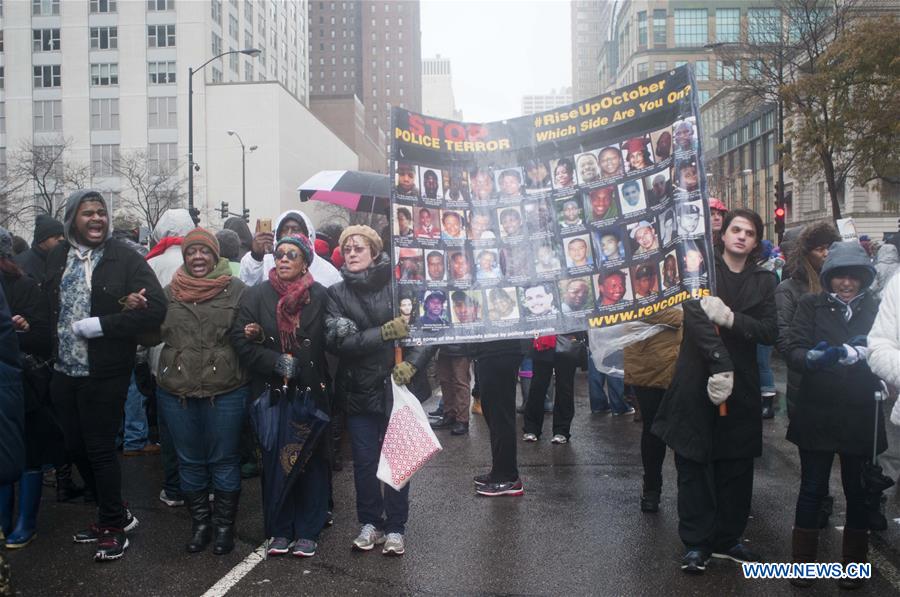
[{"xmin": 44, "ymin": 189, "xmax": 166, "ymax": 561}]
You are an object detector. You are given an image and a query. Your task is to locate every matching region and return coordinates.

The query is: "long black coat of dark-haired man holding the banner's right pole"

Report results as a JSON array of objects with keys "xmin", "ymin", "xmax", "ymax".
[{"xmin": 653, "ymin": 257, "xmax": 778, "ymax": 462}]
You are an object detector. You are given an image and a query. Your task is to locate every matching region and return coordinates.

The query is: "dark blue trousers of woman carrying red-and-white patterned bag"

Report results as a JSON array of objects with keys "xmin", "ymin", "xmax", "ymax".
[{"xmin": 347, "ymin": 415, "xmax": 409, "ymax": 534}]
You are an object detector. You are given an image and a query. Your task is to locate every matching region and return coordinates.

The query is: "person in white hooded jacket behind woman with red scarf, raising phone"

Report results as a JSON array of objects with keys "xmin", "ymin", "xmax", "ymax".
[{"xmin": 241, "ymin": 210, "xmax": 342, "ymax": 288}]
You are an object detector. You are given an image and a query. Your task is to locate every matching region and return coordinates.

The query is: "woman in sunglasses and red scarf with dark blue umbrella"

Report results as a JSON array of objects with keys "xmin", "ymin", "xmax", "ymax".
[{"xmin": 231, "ymin": 232, "xmax": 331, "ymax": 558}]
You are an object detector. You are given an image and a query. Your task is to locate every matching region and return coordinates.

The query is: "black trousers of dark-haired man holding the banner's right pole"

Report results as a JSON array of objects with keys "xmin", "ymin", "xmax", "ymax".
[{"xmin": 675, "ymin": 452, "xmax": 753, "ymax": 552}]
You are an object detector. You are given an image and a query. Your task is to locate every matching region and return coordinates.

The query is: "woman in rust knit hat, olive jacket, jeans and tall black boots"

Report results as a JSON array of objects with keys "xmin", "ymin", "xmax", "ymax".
[{"xmin": 157, "ymin": 228, "xmax": 249, "ymax": 555}]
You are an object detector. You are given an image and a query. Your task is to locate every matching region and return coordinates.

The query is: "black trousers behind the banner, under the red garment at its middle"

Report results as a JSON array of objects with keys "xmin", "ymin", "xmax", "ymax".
[{"xmin": 525, "ymin": 355, "xmax": 578, "ymax": 439}]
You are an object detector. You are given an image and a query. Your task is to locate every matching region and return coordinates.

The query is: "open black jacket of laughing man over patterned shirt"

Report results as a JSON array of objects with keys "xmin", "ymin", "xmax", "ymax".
[{"xmin": 43, "ymin": 239, "xmax": 167, "ymax": 378}]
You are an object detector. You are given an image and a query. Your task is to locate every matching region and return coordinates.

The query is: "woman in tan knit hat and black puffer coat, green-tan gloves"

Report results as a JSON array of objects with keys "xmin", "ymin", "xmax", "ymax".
[{"xmin": 325, "ymin": 226, "xmax": 434, "ymax": 556}]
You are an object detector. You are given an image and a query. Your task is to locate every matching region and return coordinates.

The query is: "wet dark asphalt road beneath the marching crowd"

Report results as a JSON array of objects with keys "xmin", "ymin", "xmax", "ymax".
[{"xmin": 9, "ymin": 356, "xmax": 900, "ymax": 597}]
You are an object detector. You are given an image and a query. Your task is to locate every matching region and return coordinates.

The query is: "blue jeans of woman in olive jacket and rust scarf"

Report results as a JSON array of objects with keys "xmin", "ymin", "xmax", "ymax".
[{"xmin": 156, "ymin": 386, "xmax": 250, "ymax": 491}]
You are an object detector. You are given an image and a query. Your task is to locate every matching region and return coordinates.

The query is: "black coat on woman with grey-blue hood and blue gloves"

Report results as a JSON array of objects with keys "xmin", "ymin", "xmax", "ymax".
[{"xmin": 787, "ymin": 292, "xmax": 887, "ymax": 456}]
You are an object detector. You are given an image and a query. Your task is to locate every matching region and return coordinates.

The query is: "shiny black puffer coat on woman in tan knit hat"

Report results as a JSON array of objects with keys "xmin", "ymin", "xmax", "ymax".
[{"xmin": 325, "ymin": 253, "xmax": 435, "ymax": 416}]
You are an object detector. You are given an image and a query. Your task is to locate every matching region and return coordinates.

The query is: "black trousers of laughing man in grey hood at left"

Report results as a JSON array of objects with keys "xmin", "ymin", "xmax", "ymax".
[{"xmin": 50, "ymin": 372, "xmax": 131, "ymax": 529}]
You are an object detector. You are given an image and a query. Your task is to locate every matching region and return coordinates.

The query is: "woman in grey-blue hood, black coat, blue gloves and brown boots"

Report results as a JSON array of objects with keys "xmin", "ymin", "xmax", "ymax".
[{"xmin": 787, "ymin": 241, "xmax": 884, "ymax": 589}]
